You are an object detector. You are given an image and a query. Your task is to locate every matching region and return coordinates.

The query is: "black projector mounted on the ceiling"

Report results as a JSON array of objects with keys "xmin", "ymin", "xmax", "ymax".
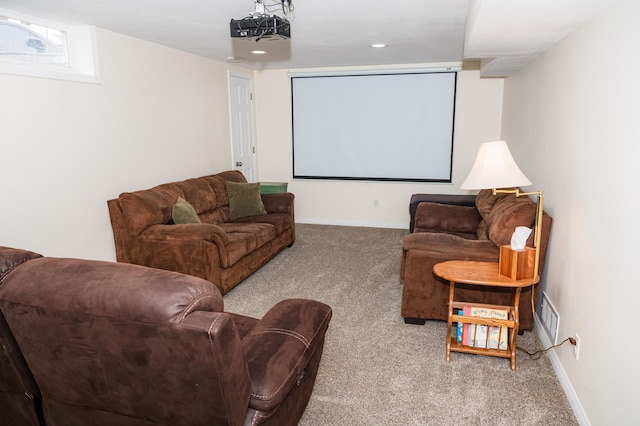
[{"xmin": 229, "ymin": 0, "xmax": 291, "ymax": 41}]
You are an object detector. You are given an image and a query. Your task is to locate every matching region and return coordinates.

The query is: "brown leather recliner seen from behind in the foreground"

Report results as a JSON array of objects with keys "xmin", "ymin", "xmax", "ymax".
[{"xmin": 0, "ymin": 248, "xmax": 332, "ymax": 426}]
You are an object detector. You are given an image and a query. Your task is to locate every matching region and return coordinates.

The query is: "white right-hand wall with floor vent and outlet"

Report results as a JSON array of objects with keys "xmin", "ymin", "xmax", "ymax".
[{"xmin": 503, "ymin": 1, "xmax": 640, "ymax": 425}]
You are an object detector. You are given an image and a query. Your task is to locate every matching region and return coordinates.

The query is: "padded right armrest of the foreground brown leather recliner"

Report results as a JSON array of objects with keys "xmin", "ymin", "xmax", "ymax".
[{"xmin": 242, "ymin": 299, "xmax": 332, "ymax": 411}]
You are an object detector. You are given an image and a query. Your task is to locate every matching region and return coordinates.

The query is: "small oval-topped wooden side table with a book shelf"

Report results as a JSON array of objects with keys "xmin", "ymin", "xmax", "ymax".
[{"xmin": 433, "ymin": 260, "xmax": 540, "ymax": 370}]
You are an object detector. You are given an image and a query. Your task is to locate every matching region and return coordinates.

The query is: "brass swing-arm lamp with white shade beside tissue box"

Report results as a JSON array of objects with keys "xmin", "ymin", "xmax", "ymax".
[{"xmin": 460, "ymin": 141, "xmax": 543, "ymax": 275}]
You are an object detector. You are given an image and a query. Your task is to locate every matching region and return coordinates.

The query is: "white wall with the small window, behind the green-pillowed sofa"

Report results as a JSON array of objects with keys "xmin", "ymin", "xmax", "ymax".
[{"xmin": 0, "ymin": 30, "xmax": 240, "ymax": 260}]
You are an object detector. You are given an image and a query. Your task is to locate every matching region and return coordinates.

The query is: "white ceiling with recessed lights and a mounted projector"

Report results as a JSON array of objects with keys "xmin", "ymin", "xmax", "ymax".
[{"xmin": 0, "ymin": 0, "xmax": 617, "ymax": 77}]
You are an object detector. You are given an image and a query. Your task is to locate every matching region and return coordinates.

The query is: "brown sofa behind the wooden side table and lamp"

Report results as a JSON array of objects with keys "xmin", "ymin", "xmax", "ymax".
[{"xmin": 400, "ymin": 190, "xmax": 551, "ymax": 330}]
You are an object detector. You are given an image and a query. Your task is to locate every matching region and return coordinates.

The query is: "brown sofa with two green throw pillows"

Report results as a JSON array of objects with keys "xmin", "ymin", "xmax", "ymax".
[{"xmin": 107, "ymin": 171, "xmax": 295, "ymax": 294}]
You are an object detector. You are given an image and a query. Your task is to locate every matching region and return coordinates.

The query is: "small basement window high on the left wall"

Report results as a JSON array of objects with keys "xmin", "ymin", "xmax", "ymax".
[{"xmin": 0, "ymin": 9, "xmax": 100, "ymax": 83}]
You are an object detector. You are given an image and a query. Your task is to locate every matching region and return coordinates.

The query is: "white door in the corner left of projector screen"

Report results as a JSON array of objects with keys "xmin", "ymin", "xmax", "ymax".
[{"xmin": 229, "ymin": 74, "xmax": 258, "ymax": 182}]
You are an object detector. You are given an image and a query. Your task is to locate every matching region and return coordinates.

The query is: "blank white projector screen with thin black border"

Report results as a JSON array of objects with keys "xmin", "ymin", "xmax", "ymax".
[{"xmin": 291, "ymin": 72, "xmax": 457, "ymax": 182}]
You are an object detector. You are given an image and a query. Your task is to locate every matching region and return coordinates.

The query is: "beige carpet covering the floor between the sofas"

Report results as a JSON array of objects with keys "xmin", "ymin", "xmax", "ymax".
[{"xmin": 224, "ymin": 225, "xmax": 577, "ymax": 425}]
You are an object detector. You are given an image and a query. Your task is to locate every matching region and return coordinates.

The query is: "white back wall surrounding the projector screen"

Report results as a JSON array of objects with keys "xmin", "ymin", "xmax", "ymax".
[{"xmin": 256, "ymin": 70, "xmax": 503, "ymax": 228}]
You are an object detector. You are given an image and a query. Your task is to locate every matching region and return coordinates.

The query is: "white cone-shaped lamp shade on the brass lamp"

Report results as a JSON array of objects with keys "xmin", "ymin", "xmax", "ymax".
[{"xmin": 460, "ymin": 141, "xmax": 531, "ymax": 189}]
